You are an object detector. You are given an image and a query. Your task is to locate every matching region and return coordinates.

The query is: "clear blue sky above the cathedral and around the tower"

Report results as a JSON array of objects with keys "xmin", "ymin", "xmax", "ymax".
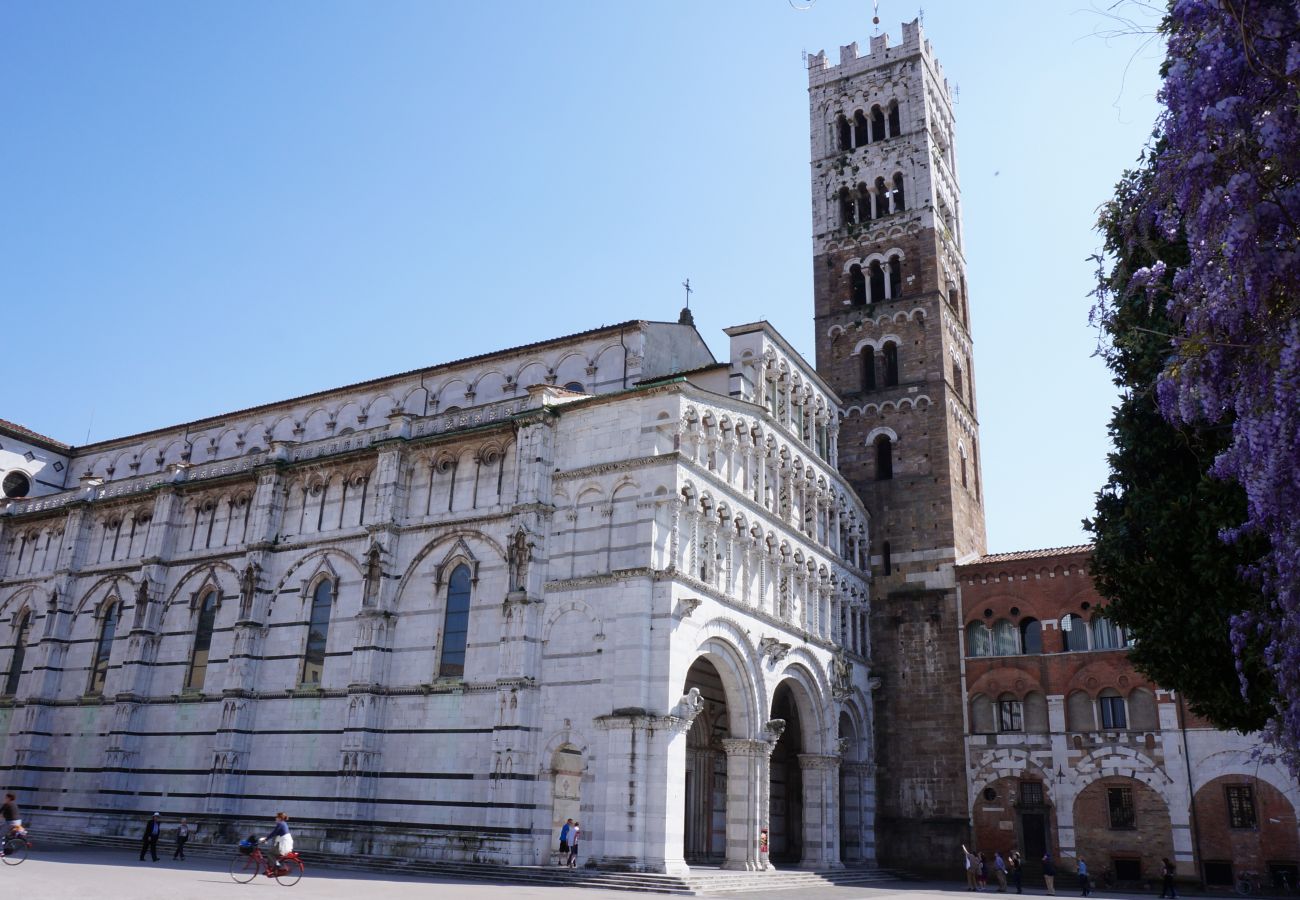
[{"xmin": 0, "ymin": 0, "xmax": 1160, "ymax": 551}]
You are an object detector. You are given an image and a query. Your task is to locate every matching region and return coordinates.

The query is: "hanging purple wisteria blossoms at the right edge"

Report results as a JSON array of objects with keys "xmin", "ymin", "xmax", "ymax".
[{"xmin": 1107, "ymin": 0, "xmax": 1300, "ymax": 770}]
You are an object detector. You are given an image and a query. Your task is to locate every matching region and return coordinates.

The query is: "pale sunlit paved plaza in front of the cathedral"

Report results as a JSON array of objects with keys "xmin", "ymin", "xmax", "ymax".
[{"xmin": 0, "ymin": 844, "xmax": 1248, "ymax": 900}]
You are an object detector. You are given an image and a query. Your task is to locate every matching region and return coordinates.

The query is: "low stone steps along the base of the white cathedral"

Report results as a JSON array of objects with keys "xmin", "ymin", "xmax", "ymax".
[{"xmin": 50, "ymin": 831, "xmax": 902, "ymax": 896}]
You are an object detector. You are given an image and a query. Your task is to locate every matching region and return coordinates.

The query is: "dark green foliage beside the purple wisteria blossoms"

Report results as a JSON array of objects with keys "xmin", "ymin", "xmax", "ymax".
[{"xmin": 1084, "ymin": 154, "xmax": 1277, "ymax": 731}]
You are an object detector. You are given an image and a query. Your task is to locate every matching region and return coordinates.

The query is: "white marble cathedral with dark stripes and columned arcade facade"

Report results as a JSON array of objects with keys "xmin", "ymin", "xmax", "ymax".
[{"xmin": 0, "ymin": 321, "xmax": 875, "ymax": 873}]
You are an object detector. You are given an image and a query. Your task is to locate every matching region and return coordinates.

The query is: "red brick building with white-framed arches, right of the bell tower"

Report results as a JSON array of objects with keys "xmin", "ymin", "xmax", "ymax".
[{"xmin": 956, "ymin": 546, "xmax": 1300, "ymax": 884}]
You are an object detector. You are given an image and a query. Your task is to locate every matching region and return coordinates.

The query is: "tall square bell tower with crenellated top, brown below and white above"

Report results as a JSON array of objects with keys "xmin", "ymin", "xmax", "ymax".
[{"xmin": 809, "ymin": 22, "xmax": 985, "ymax": 869}]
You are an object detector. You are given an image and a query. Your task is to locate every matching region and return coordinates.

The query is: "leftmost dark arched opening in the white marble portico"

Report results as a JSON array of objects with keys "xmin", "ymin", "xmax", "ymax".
[{"xmin": 683, "ymin": 658, "xmax": 731, "ymax": 864}]
